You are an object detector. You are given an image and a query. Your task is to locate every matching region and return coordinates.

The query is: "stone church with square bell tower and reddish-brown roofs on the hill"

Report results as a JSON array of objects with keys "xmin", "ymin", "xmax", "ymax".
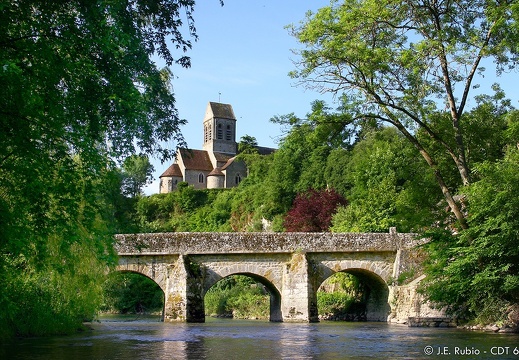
[{"xmin": 159, "ymin": 102, "xmax": 274, "ymax": 194}]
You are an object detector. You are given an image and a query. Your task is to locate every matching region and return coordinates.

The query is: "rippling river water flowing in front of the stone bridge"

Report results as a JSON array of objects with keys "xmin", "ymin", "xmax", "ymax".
[{"xmin": 0, "ymin": 318, "xmax": 519, "ymax": 360}]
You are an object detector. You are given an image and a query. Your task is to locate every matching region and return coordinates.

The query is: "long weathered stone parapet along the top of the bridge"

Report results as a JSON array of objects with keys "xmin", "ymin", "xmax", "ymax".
[{"xmin": 115, "ymin": 231, "xmax": 426, "ymax": 255}]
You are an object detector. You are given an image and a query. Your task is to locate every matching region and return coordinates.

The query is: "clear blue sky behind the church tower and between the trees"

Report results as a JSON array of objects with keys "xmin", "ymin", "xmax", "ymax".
[{"xmin": 145, "ymin": 0, "xmax": 518, "ymax": 195}]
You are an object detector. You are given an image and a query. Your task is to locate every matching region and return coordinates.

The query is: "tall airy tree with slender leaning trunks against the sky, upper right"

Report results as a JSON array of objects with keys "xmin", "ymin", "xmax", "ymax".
[{"xmin": 291, "ymin": 0, "xmax": 519, "ymax": 228}]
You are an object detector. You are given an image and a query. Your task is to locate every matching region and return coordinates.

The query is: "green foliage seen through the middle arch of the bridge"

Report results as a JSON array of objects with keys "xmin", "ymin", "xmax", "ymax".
[{"xmin": 204, "ymin": 275, "xmax": 270, "ymax": 319}]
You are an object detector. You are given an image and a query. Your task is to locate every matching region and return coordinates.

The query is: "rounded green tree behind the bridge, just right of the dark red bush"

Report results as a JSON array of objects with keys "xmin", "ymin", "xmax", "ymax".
[{"xmin": 330, "ymin": 128, "xmax": 441, "ymax": 232}]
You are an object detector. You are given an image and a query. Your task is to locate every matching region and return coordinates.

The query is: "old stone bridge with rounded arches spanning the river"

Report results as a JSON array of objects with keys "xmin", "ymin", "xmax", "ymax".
[{"xmin": 115, "ymin": 229, "xmax": 441, "ymax": 323}]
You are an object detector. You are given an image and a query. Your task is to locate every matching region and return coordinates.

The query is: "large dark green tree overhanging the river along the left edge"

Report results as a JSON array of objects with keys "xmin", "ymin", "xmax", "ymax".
[{"xmin": 0, "ymin": 0, "xmax": 213, "ymax": 336}]
